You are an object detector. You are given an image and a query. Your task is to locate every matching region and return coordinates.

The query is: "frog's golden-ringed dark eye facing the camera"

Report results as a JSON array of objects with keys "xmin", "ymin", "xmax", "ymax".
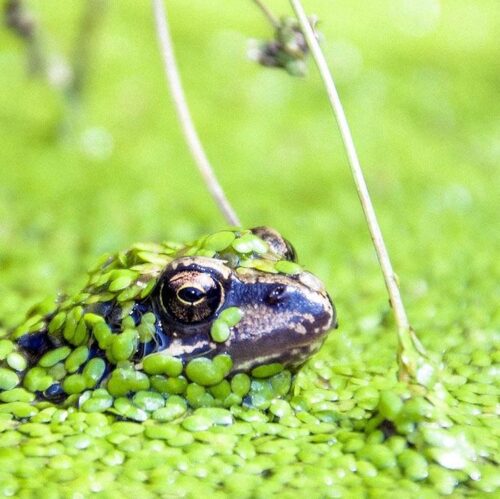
[{"xmin": 160, "ymin": 270, "xmax": 224, "ymax": 324}]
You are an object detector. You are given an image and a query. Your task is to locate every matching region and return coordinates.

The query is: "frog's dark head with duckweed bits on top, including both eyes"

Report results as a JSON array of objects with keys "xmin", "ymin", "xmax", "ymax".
[{"xmin": 149, "ymin": 227, "xmax": 336, "ymax": 372}]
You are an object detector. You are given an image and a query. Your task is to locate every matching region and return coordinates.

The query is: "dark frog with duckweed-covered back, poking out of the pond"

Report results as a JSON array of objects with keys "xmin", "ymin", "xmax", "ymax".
[{"xmin": 0, "ymin": 227, "xmax": 337, "ymax": 410}]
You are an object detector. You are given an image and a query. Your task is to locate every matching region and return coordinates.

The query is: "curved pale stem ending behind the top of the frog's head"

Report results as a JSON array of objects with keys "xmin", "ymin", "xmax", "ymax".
[{"xmin": 152, "ymin": 0, "xmax": 241, "ymax": 226}]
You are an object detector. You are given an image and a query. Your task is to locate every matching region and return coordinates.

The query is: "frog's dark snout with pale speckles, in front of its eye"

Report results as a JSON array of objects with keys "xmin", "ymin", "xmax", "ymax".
[{"xmin": 225, "ymin": 272, "xmax": 336, "ymax": 371}]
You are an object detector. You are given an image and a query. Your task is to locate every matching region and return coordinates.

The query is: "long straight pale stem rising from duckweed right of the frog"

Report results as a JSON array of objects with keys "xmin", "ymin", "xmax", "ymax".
[{"xmin": 290, "ymin": 0, "xmax": 424, "ymax": 377}]
